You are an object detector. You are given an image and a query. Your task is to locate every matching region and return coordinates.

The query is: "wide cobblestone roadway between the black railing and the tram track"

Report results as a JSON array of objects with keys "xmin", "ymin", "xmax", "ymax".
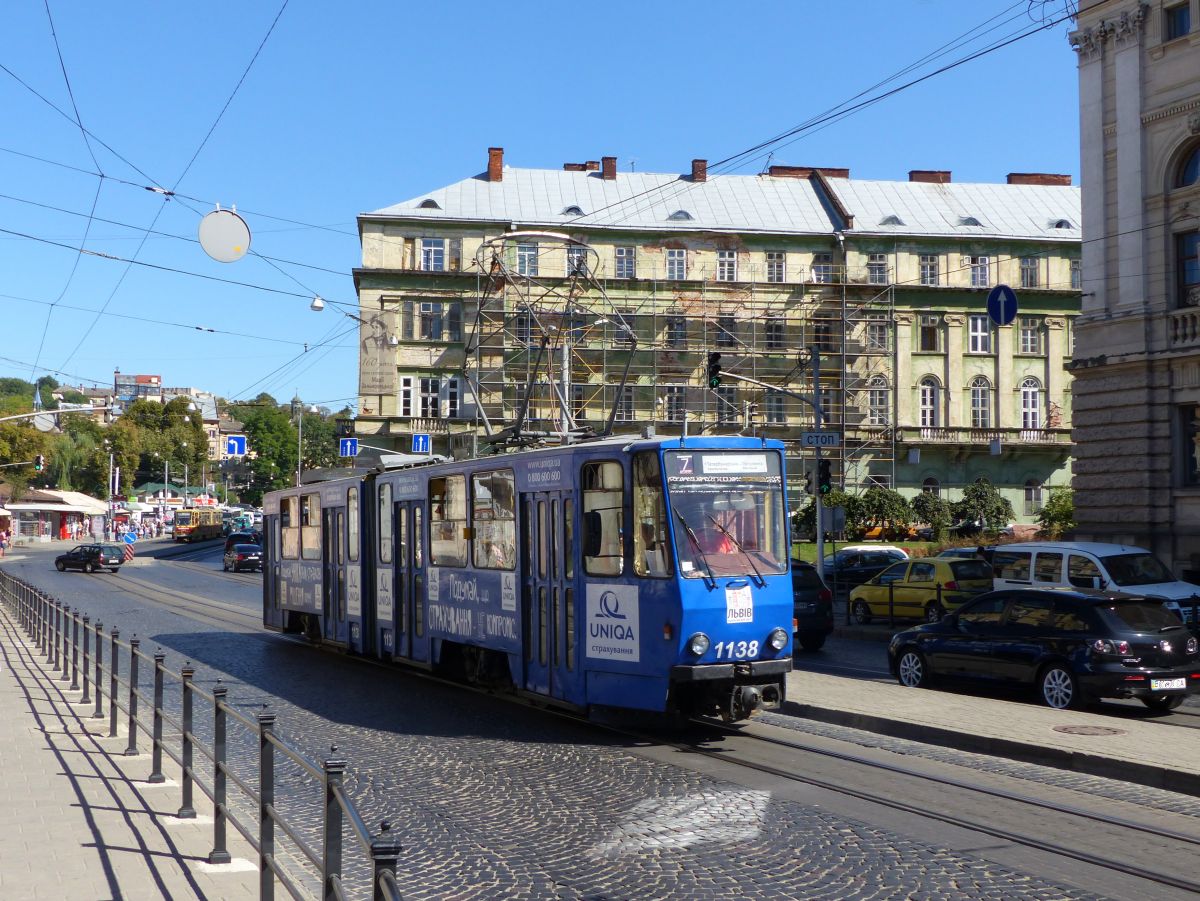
[{"xmin": 11, "ymin": 561, "xmax": 1113, "ymax": 901}]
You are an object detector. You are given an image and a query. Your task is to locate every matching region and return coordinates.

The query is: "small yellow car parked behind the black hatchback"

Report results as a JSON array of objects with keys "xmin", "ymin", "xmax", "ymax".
[{"xmin": 850, "ymin": 557, "xmax": 992, "ymax": 625}]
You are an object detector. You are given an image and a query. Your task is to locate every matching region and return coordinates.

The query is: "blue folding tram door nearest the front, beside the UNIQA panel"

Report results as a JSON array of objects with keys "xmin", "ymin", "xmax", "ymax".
[{"xmin": 521, "ymin": 491, "xmax": 576, "ymax": 698}]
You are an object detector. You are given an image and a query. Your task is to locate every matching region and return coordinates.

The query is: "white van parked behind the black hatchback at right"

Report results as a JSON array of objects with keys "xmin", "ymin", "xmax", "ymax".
[{"xmin": 991, "ymin": 541, "xmax": 1200, "ymax": 623}]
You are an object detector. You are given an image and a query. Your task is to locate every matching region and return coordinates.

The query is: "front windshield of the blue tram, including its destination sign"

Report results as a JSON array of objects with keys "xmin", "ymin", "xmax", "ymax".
[{"xmin": 664, "ymin": 450, "xmax": 788, "ymax": 581}]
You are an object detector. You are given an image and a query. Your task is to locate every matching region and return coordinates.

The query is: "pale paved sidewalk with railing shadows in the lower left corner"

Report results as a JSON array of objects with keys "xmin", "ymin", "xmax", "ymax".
[{"xmin": 0, "ymin": 609, "xmax": 258, "ymax": 901}]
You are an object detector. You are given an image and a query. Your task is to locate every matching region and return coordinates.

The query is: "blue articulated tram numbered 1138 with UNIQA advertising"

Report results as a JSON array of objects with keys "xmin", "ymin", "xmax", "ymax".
[{"xmin": 263, "ymin": 436, "xmax": 792, "ymax": 720}]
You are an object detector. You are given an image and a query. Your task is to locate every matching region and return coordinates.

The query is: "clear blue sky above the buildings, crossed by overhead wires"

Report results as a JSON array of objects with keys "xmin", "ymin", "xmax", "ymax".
[{"xmin": 0, "ymin": 0, "xmax": 1079, "ymax": 408}]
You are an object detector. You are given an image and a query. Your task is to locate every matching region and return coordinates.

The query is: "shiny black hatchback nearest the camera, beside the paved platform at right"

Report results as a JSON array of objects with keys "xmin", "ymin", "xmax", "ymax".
[{"xmin": 888, "ymin": 589, "xmax": 1200, "ymax": 710}]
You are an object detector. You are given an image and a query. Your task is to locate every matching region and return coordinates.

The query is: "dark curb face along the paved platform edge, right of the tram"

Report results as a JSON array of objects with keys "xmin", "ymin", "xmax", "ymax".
[{"xmin": 780, "ymin": 701, "xmax": 1200, "ymax": 797}]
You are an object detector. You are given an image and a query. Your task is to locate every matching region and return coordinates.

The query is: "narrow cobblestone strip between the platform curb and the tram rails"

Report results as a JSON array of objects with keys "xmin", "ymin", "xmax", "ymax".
[{"xmin": 762, "ymin": 714, "xmax": 1200, "ymax": 817}]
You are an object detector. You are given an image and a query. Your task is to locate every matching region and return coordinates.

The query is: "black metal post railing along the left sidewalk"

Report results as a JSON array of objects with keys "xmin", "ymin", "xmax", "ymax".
[{"xmin": 0, "ymin": 572, "xmax": 401, "ymax": 901}]
